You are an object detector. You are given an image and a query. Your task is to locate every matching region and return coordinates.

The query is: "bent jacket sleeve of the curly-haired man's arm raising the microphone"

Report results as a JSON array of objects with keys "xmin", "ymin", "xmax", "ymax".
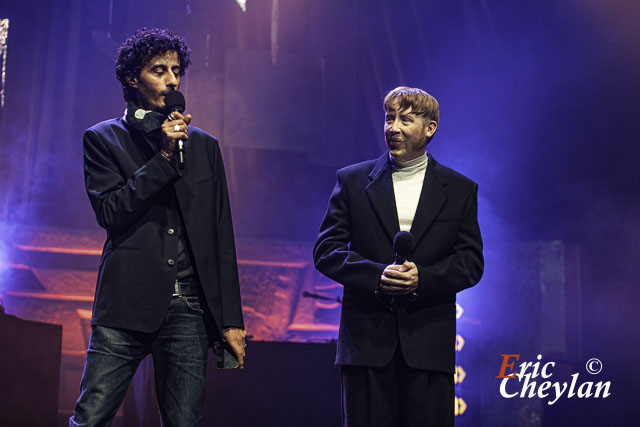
[{"xmin": 83, "ymin": 129, "xmax": 178, "ymax": 232}]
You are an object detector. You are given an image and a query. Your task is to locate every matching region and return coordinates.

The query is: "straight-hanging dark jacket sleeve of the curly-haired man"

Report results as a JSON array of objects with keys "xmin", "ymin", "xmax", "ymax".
[{"xmin": 212, "ymin": 139, "xmax": 244, "ymax": 329}]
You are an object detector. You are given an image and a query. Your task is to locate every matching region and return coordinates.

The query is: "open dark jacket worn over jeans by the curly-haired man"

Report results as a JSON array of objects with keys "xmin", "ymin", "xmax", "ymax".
[{"xmin": 83, "ymin": 114, "xmax": 244, "ymax": 342}]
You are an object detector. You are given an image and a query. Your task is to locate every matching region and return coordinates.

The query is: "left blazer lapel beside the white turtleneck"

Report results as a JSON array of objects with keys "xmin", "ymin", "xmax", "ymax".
[{"xmin": 365, "ymin": 153, "xmax": 400, "ymax": 246}]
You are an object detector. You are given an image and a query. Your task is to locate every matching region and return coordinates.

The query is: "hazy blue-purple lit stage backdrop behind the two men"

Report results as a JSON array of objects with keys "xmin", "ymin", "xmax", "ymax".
[{"xmin": 0, "ymin": 0, "xmax": 640, "ymax": 425}]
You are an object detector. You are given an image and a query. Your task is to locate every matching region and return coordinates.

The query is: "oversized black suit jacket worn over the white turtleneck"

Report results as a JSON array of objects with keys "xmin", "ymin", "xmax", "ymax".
[{"xmin": 314, "ymin": 153, "xmax": 484, "ymax": 373}]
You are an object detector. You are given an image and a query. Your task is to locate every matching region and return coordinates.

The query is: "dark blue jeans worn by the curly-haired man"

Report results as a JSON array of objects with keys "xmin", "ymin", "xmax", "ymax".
[{"xmin": 69, "ymin": 296, "xmax": 210, "ymax": 426}]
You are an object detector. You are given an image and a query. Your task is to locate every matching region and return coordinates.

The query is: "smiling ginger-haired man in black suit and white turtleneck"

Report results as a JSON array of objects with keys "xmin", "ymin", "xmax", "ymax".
[{"xmin": 314, "ymin": 86, "xmax": 484, "ymax": 427}]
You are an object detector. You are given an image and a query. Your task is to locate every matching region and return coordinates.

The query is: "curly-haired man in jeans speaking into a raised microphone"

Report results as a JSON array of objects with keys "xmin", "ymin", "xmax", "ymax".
[{"xmin": 69, "ymin": 28, "xmax": 246, "ymax": 426}]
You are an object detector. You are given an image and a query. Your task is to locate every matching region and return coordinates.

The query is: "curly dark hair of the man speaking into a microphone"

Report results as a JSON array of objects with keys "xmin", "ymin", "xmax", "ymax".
[{"xmin": 116, "ymin": 28, "xmax": 191, "ymax": 102}]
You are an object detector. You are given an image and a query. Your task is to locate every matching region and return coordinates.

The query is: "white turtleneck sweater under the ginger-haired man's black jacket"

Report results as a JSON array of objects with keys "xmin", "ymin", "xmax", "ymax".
[{"xmin": 389, "ymin": 152, "xmax": 427, "ymax": 231}]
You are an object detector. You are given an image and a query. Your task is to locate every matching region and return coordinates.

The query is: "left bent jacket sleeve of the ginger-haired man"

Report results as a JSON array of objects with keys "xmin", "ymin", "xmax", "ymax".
[{"xmin": 313, "ymin": 171, "xmax": 386, "ymax": 293}]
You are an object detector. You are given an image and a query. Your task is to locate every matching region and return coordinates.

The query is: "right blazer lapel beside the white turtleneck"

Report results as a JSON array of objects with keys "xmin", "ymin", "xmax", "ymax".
[{"xmin": 411, "ymin": 154, "xmax": 449, "ymax": 248}]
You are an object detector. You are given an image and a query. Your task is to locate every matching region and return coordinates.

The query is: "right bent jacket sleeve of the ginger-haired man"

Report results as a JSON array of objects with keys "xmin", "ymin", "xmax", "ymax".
[{"xmin": 417, "ymin": 184, "xmax": 484, "ymax": 301}]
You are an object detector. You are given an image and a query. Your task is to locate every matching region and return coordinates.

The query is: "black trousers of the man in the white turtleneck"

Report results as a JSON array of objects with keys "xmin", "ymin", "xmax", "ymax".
[{"xmin": 342, "ymin": 348, "xmax": 455, "ymax": 427}]
